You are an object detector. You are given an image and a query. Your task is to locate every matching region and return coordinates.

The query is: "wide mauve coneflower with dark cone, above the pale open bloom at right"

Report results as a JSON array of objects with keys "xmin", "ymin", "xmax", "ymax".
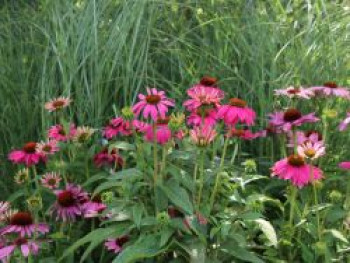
[{"xmin": 269, "ymin": 109, "xmax": 320, "ymax": 132}]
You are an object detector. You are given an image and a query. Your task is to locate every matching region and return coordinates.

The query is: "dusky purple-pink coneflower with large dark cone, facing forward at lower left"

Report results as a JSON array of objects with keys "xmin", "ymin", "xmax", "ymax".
[{"xmin": 52, "ymin": 184, "xmax": 89, "ymax": 222}]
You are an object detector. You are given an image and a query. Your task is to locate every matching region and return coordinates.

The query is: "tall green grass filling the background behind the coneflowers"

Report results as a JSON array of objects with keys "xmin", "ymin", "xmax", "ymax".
[{"xmin": 0, "ymin": 0, "xmax": 350, "ymax": 197}]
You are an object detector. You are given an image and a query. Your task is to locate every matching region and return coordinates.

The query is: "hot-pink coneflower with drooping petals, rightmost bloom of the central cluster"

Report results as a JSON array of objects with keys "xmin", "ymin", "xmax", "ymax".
[{"xmin": 217, "ymin": 98, "xmax": 256, "ymax": 125}]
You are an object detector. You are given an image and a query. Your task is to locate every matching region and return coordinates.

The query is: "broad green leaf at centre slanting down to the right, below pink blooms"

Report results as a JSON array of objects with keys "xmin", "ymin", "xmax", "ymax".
[{"xmin": 160, "ymin": 181, "xmax": 193, "ymax": 214}]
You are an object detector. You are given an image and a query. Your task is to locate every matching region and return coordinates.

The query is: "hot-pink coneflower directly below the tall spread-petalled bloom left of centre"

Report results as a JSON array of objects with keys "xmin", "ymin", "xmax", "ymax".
[{"xmin": 145, "ymin": 118, "xmax": 171, "ymax": 145}]
